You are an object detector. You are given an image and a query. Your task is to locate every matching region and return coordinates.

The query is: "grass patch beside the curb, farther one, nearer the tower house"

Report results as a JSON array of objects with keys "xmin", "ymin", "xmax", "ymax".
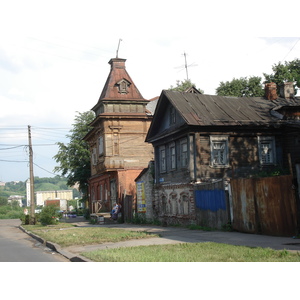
[{"xmin": 24, "ymin": 223, "xmax": 158, "ymax": 247}]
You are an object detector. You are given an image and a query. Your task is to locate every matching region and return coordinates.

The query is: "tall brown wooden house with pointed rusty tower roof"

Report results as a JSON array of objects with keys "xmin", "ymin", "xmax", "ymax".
[{"xmin": 84, "ymin": 58, "xmax": 153, "ymax": 213}]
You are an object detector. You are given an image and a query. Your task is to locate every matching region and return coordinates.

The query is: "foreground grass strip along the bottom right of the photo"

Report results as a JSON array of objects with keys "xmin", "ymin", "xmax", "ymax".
[{"xmin": 82, "ymin": 242, "xmax": 300, "ymax": 262}]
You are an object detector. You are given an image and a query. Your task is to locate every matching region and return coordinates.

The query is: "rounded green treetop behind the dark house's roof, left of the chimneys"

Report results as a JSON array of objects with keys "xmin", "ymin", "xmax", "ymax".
[{"xmin": 216, "ymin": 76, "xmax": 264, "ymax": 97}]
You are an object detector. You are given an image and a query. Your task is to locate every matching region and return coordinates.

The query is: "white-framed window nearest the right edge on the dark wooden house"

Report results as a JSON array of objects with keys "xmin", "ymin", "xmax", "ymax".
[{"xmin": 258, "ymin": 136, "xmax": 276, "ymax": 165}]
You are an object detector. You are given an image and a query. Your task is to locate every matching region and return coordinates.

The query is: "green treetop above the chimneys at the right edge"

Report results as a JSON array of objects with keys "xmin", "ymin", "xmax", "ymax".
[{"xmin": 264, "ymin": 59, "xmax": 300, "ymax": 94}]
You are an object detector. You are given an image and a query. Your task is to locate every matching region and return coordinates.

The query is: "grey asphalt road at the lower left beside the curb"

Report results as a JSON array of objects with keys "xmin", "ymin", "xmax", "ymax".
[{"xmin": 0, "ymin": 220, "xmax": 69, "ymax": 262}]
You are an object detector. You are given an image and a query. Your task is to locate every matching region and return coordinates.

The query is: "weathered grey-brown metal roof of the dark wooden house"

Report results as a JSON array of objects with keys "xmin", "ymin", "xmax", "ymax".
[{"xmin": 146, "ymin": 90, "xmax": 300, "ymax": 141}]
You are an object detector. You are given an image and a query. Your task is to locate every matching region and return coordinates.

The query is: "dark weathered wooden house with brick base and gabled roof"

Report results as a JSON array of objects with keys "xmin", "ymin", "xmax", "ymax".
[{"xmin": 146, "ymin": 83, "xmax": 300, "ymax": 230}]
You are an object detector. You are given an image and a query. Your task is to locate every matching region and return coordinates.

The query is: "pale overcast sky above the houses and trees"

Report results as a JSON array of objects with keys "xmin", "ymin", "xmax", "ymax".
[{"xmin": 0, "ymin": 0, "xmax": 300, "ymax": 181}]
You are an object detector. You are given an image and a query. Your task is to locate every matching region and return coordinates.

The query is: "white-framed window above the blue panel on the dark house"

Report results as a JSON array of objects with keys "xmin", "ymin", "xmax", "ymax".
[{"xmin": 210, "ymin": 135, "xmax": 229, "ymax": 168}]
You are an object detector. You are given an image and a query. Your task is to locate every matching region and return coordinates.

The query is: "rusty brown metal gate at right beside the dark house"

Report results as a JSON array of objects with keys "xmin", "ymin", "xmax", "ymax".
[{"xmin": 230, "ymin": 175, "xmax": 297, "ymax": 236}]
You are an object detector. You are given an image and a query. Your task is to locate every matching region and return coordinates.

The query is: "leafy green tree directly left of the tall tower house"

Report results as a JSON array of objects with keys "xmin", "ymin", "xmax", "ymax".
[{"xmin": 54, "ymin": 111, "xmax": 95, "ymax": 193}]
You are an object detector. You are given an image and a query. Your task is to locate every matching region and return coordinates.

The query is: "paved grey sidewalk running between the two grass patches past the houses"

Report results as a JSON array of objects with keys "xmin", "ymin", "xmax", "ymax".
[{"xmin": 31, "ymin": 218, "xmax": 300, "ymax": 261}]
